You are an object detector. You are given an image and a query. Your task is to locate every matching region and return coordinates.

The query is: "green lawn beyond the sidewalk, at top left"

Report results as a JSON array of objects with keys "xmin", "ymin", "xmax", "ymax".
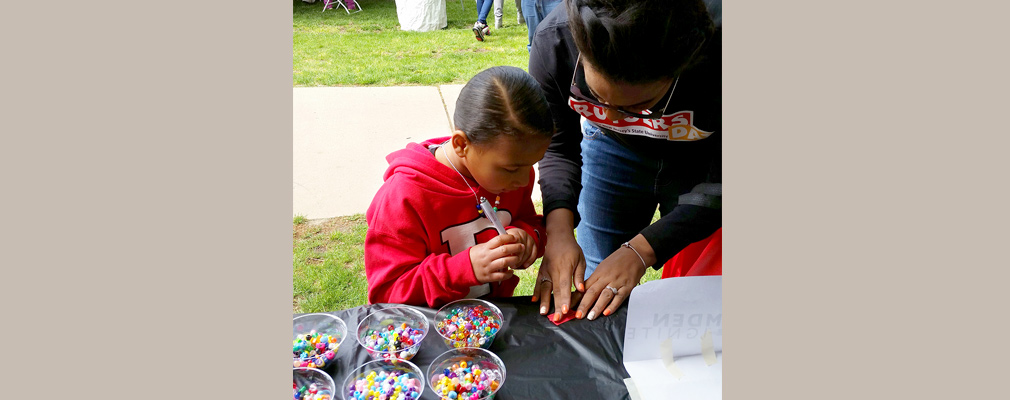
[{"xmin": 293, "ymin": 0, "xmax": 529, "ymax": 86}]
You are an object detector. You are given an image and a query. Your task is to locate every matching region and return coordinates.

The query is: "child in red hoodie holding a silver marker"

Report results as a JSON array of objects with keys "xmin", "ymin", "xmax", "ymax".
[{"xmin": 365, "ymin": 67, "xmax": 553, "ymax": 308}]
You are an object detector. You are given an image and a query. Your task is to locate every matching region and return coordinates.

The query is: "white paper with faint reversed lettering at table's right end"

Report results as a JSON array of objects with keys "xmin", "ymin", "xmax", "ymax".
[{"xmin": 624, "ymin": 276, "xmax": 722, "ymax": 400}]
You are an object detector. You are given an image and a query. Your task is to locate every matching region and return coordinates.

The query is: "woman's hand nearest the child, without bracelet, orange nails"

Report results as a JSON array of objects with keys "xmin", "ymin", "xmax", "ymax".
[{"xmin": 532, "ymin": 208, "xmax": 586, "ymax": 321}]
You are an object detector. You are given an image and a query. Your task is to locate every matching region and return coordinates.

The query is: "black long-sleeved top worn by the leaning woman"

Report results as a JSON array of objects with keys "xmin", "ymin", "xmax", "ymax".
[{"xmin": 529, "ymin": 1, "xmax": 722, "ymax": 268}]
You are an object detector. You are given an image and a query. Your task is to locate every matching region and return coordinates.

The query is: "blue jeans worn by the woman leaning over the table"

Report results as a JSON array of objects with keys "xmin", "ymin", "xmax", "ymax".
[{"xmin": 576, "ymin": 120, "xmax": 694, "ymax": 279}]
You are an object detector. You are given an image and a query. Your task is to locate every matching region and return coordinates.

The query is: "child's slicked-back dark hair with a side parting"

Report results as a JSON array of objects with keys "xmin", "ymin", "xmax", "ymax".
[{"xmin": 452, "ymin": 67, "xmax": 554, "ymax": 144}]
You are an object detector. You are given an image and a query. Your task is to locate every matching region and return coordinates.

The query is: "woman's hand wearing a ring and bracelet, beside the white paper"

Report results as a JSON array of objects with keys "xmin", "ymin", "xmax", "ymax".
[{"xmin": 575, "ymin": 234, "xmax": 655, "ymax": 320}]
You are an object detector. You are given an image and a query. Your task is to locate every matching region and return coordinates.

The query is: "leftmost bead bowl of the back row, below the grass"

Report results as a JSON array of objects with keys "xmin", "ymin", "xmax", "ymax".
[{"xmin": 291, "ymin": 314, "xmax": 347, "ymax": 369}]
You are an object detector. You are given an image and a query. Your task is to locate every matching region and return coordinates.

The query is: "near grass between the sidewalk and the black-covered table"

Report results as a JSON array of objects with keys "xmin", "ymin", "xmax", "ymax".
[{"xmin": 292, "ymin": 202, "xmax": 662, "ymax": 313}]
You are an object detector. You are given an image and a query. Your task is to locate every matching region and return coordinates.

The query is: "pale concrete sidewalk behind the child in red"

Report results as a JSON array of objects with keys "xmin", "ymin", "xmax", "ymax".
[{"xmin": 292, "ymin": 85, "xmax": 540, "ymax": 219}]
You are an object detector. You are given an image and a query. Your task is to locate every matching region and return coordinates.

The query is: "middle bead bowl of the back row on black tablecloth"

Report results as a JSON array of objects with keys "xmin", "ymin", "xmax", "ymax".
[{"xmin": 357, "ymin": 306, "xmax": 428, "ymax": 360}]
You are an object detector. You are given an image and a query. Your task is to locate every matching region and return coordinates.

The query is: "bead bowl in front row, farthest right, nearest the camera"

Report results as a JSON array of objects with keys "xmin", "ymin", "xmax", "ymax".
[{"xmin": 428, "ymin": 347, "xmax": 505, "ymax": 400}]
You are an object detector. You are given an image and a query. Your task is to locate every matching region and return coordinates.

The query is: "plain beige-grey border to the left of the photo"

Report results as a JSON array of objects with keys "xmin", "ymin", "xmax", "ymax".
[{"xmin": 0, "ymin": 1, "xmax": 292, "ymax": 399}]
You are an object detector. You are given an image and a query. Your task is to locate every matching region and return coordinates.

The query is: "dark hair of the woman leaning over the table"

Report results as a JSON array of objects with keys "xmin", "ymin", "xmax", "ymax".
[{"xmin": 566, "ymin": 0, "xmax": 715, "ymax": 84}]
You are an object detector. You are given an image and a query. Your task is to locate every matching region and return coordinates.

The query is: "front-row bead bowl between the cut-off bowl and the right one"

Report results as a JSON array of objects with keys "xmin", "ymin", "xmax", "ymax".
[{"xmin": 341, "ymin": 359, "xmax": 424, "ymax": 400}]
